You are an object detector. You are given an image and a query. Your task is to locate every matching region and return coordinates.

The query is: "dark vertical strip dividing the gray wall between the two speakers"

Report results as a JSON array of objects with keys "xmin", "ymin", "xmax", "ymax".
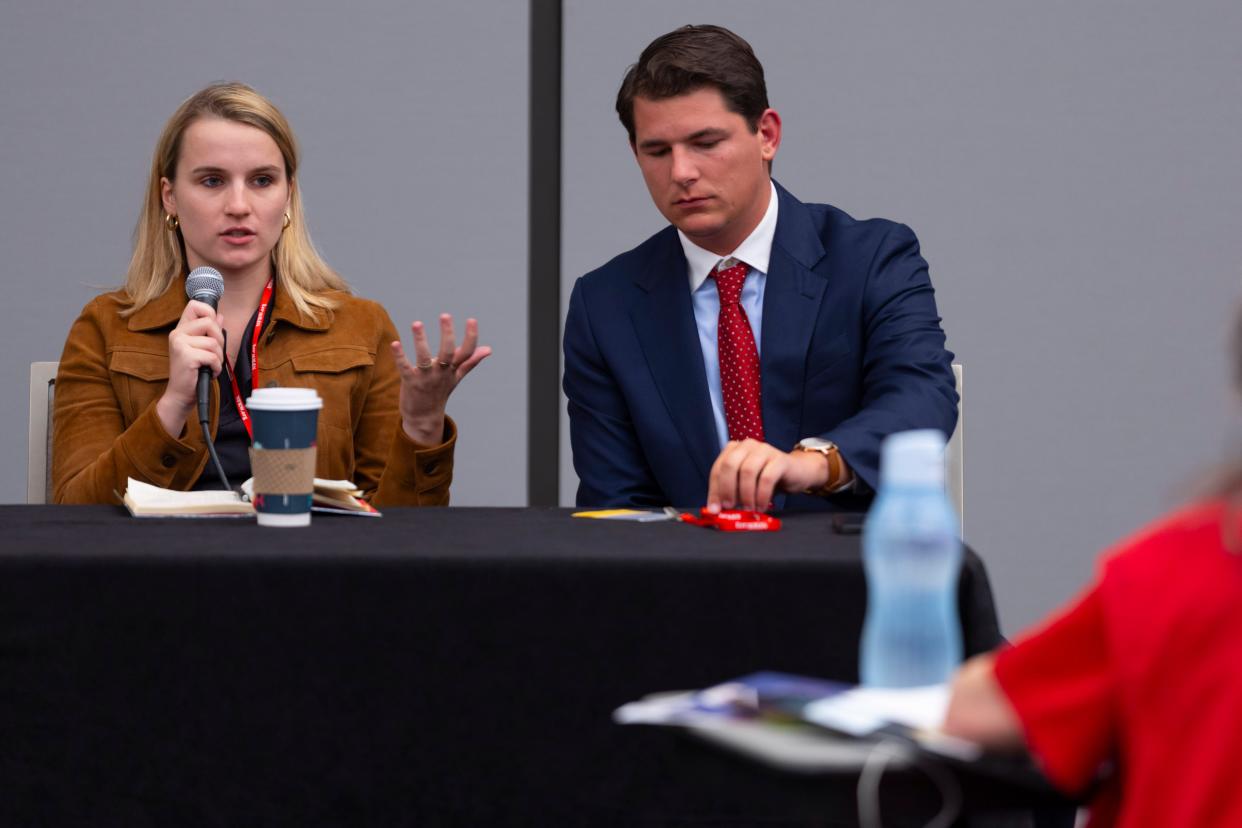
[{"xmin": 527, "ymin": 0, "xmax": 561, "ymax": 506}]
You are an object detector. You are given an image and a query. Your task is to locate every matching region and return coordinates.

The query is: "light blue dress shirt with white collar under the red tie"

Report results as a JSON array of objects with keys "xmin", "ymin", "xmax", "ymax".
[{"xmin": 677, "ymin": 184, "xmax": 777, "ymax": 448}]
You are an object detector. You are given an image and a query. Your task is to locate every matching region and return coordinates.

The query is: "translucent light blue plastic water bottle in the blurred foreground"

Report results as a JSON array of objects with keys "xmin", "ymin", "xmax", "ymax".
[{"xmin": 859, "ymin": 428, "xmax": 961, "ymax": 688}]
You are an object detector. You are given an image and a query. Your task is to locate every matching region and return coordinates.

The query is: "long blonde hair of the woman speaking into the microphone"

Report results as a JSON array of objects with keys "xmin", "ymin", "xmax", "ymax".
[{"xmin": 123, "ymin": 82, "xmax": 349, "ymax": 317}]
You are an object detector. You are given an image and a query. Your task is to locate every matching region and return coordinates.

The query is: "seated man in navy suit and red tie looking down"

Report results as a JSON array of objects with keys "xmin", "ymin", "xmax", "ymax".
[{"xmin": 564, "ymin": 26, "xmax": 958, "ymax": 510}]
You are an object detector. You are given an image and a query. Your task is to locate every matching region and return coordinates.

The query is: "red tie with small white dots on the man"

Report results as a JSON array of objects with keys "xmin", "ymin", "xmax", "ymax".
[{"xmin": 713, "ymin": 258, "xmax": 764, "ymax": 441}]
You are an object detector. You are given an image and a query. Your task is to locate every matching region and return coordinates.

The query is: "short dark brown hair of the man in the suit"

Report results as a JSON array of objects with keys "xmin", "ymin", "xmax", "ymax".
[{"xmin": 617, "ymin": 26, "xmax": 768, "ymax": 144}]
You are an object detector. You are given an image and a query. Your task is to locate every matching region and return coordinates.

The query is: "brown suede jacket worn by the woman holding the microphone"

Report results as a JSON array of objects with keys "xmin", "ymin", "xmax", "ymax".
[{"xmin": 52, "ymin": 278, "xmax": 457, "ymax": 506}]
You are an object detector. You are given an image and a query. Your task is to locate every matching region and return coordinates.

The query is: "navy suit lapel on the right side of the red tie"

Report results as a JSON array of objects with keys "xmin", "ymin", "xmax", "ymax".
[{"xmin": 759, "ymin": 184, "xmax": 827, "ymax": 451}]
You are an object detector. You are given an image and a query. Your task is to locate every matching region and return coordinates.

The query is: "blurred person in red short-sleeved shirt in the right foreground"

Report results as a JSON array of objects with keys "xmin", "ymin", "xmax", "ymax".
[{"xmin": 944, "ymin": 315, "xmax": 1242, "ymax": 828}]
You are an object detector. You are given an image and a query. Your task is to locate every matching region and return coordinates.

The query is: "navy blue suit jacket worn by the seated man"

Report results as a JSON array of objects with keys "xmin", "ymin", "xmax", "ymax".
[{"xmin": 564, "ymin": 185, "xmax": 958, "ymax": 508}]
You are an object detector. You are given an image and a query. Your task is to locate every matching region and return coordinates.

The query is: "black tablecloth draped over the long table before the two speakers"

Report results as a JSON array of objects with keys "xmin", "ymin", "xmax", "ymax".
[{"xmin": 0, "ymin": 506, "xmax": 1048, "ymax": 826}]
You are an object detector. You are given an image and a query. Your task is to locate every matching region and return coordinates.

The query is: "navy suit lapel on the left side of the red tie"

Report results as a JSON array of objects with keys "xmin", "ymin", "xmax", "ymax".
[{"xmin": 630, "ymin": 227, "xmax": 719, "ymax": 481}]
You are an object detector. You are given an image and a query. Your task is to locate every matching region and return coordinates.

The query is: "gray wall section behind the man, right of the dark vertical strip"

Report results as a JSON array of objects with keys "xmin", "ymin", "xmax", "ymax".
[{"xmin": 561, "ymin": 0, "xmax": 1242, "ymax": 632}]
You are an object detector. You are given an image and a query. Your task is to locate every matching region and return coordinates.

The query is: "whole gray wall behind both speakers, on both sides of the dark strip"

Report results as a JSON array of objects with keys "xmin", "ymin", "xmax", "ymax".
[{"xmin": 0, "ymin": 0, "xmax": 1242, "ymax": 631}]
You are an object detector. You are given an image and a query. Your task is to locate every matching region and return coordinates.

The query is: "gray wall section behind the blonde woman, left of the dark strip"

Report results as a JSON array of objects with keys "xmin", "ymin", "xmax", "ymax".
[{"xmin": 0, "ymin": 0, "xmax": 529, "ymax": 505}]
